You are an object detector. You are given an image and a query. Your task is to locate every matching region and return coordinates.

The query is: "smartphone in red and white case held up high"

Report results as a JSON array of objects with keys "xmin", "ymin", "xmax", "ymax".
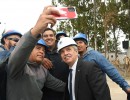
[{"xmin": 52, "ymin": 7, "xmax": 77, "ymax": 20}]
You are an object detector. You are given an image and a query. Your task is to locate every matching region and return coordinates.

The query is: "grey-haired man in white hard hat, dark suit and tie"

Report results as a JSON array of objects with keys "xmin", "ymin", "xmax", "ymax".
[{"xmin": 58, "ymin": 37, "xmax": 111, "ymax": 100}]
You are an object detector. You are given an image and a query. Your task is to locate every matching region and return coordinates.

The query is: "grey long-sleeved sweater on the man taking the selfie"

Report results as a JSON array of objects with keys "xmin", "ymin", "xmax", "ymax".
[{"xmin": 7, "ymin": 32, "xmax": 65, "ymax": 100}]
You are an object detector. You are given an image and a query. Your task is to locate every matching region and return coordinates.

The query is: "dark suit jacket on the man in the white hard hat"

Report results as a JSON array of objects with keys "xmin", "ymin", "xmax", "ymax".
[{"xmin": 64, "ymin": 59, "xmax": 111, "ymax": 100}]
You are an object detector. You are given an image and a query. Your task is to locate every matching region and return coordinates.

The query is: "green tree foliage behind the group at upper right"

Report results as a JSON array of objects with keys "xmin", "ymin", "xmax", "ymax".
[{"xmin": 53, "ymin": 0, "xmax": 130, "ymax": 53}]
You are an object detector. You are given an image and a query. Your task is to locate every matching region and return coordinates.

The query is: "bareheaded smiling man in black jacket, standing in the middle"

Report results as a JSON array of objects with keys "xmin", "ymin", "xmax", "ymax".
[{"xmin": 42, "ymin": 28, "xmax": 69, "ymax": 100}]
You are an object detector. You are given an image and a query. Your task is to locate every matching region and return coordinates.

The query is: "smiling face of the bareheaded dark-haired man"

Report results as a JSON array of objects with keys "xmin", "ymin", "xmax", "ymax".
[{"xmin": 43, "ymin": 30, "xmax": 56, "ymax": 47}]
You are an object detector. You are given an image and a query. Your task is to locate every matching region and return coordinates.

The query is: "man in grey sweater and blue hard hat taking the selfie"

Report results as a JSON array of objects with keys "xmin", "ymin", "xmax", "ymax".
[{"xmin": 6, "ymin": 6, "xmax": 65, "ymax": 100}]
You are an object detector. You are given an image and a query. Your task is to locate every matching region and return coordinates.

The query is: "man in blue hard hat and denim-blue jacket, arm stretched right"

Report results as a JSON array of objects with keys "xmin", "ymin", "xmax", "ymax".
[{"xmin": 73, "ymin": 33, "xmax": 130, "ymax": 93}]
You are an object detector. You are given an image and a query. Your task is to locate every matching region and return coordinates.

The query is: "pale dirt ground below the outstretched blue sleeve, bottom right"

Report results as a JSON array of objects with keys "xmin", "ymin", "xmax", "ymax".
[{"xmin": 107, "ymin": 77, "xmax": 130, "ymax": 100}]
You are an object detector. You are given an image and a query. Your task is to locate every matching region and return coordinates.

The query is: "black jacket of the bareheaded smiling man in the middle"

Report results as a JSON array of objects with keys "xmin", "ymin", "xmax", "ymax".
[{"xmin": 42, "ymin": 48, "xmax": 69, "ymax": 100}]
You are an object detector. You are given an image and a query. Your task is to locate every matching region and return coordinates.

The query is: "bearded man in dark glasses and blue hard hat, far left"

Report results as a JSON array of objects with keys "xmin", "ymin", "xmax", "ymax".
[{"xmin": 0, "ymin": 30, "xmax": 22, "ymax": 100}]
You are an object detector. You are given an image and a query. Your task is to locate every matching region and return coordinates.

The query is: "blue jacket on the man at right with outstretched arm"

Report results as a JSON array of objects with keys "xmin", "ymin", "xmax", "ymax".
[{"xmin": 83, "ymin": 47, "xmax": 130, "ymax": 90}]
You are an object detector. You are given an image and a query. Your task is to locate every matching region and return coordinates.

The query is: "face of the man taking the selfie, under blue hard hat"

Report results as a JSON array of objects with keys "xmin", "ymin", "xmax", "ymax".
[{"xmin": 29, "ymin": 45, "xmax": 45, "ymax": 63}]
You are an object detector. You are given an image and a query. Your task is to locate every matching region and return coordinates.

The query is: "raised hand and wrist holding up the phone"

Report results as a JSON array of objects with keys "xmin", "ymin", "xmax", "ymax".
[{"xmin": 31, "ymin": 6, "xmax": 60, "ymax": 37}]
